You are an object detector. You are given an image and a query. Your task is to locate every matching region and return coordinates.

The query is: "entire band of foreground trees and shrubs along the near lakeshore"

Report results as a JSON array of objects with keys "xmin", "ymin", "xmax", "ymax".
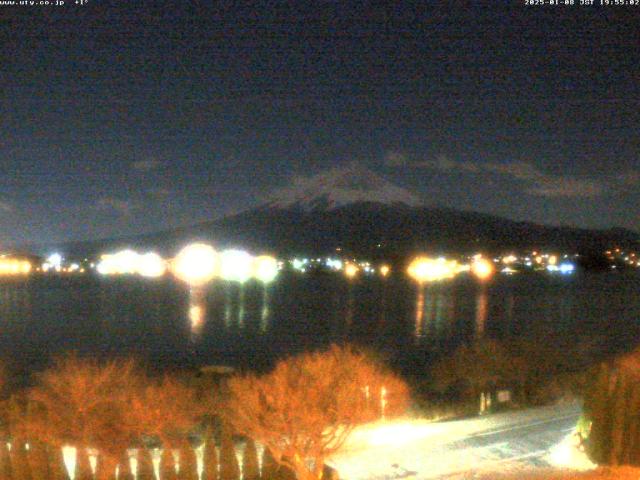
[{"xmin": 0, "ymin": 338, "xmax": 640, "ymax": 480}]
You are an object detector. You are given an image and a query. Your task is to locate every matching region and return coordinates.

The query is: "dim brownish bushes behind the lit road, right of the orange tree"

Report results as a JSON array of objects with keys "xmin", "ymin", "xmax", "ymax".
[{"xmin": 414, "ymin": 336, "xmax": 607, "ymax": 418}]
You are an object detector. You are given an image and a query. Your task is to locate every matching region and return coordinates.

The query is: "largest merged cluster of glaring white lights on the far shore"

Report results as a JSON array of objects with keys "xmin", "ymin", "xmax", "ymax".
[{"xmin": 97, "ymin": 243, "xmax": 279, "ymax": 287}]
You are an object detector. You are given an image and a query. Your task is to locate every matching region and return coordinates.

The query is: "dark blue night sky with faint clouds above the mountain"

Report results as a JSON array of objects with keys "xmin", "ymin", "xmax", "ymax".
[{"xmin": 0, "ymin": 0, "xmax": 640, "ymax": 245}]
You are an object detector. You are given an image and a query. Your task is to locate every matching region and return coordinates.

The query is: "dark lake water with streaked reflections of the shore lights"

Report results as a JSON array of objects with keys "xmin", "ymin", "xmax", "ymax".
[{"xmin": 0, "ymin": 272, "xmax": 640, "ymax": 376}]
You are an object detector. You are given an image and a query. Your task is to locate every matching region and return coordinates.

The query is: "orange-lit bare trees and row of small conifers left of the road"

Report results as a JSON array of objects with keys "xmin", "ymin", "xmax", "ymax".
[{"xmin": 0, "ymin": 346, "xmax": 408, "ymax": 480}]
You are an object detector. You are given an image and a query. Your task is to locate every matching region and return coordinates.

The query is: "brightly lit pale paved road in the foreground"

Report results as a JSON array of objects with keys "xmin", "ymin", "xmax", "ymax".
[{"xmin": 333, "ymin": 404, "xmax": 580, "ymax": 480}]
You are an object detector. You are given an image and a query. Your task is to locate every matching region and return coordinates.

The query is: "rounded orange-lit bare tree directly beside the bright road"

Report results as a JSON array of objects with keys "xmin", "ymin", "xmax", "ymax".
[{"xmin": 224, "ymin": 346, "xmax": 408, "ymax": 480}]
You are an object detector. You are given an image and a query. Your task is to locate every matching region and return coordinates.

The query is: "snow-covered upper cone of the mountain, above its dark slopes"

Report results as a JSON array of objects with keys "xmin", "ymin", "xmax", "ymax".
[{"xmin": 265, "ymin": 163, "xmax": 424, "ymax": 210}]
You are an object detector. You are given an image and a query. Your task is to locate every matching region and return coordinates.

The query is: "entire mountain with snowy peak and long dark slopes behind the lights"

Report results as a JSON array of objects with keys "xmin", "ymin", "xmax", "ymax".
[{"xmin": 30, "ymin": 163, "xmax": 640, "ymax": 260}]
